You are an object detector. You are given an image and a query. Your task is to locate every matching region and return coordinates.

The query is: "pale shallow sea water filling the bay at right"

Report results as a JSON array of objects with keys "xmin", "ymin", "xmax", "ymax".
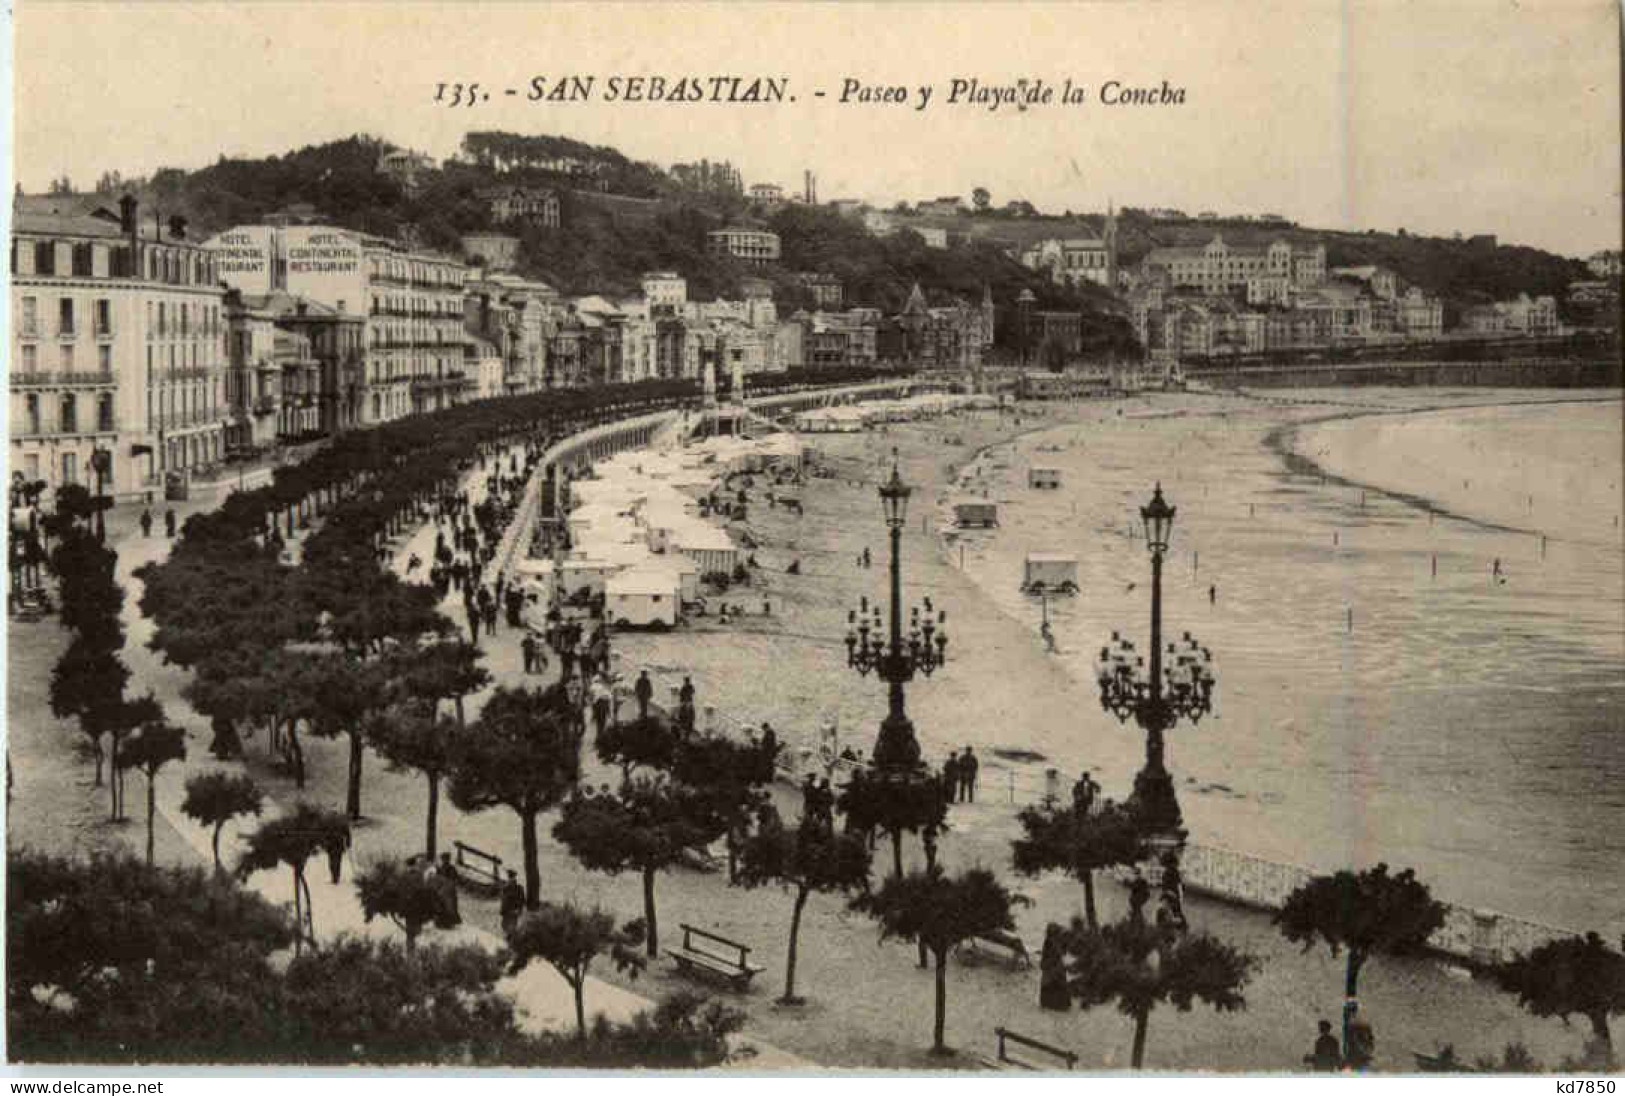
[{"xmin": 965, "ymin": 392, "xmax": 1625, "ymax": 933}]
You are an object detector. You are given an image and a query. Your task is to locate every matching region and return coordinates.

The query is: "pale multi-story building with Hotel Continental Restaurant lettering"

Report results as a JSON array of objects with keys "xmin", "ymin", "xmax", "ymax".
[{"xmin": 206, "ymin": 224, "xmax": 471, "ymax": 424}]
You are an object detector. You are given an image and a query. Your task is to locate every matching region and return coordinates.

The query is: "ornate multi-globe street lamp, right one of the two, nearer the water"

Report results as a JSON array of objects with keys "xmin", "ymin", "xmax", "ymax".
[{"xmin": 1095, "ymin": 483, "xmax": 1216, "ymax": 846}]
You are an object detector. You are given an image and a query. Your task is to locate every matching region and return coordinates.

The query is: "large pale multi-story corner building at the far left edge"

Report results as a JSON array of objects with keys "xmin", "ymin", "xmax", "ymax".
[{"xmin": 8, "ymin": 195, "xmax": 231, "ymax": 498}]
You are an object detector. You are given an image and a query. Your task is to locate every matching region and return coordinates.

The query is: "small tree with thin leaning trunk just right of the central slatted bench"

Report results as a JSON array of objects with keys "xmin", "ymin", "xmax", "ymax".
[{"xmin": 736, "ymin": 815, "xmax": 869, "ymax": 1005}]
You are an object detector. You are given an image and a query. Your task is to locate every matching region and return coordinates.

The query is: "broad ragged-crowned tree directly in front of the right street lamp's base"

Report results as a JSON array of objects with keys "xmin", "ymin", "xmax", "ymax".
[{"xmin": 1063, "ymin": 917, "xmax": 1258, "ymax": 1070}]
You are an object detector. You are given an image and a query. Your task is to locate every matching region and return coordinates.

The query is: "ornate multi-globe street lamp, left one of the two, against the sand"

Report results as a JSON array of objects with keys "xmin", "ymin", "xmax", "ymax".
[{"xmin": 847, "ymin": 449, "xmax": 947, "ymax": 769}]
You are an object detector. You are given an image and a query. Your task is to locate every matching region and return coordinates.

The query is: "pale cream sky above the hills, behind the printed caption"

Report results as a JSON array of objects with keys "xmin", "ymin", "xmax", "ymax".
[{"xmin": 15, "ymin": 0, "xmax": 1622, "ymax": 255}]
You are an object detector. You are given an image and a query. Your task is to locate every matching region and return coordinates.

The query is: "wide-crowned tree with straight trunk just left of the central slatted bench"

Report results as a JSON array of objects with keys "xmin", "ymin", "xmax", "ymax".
[{"xmin": 553, "ymin": 776, "xmax": 725, "ymax": 956}]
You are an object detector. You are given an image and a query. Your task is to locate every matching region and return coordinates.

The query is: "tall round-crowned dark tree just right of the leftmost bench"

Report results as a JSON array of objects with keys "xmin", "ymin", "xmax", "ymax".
[{"xmin": 449, "ymin": 685, "xmax": 582, "ymax": 909}]
